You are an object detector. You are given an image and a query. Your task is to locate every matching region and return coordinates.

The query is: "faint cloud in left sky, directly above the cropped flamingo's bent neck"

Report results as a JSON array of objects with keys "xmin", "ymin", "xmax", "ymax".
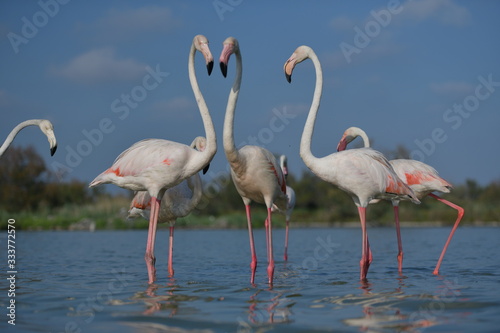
[{"xmin": 51, "ymin": 48, "xmax": 146, "ymax": 83}]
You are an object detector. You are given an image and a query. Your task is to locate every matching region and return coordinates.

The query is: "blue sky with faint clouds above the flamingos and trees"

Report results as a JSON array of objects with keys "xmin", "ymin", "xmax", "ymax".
[{"xmin": 0, "ymin": 0, "xmax": 500, "ymax": 192}]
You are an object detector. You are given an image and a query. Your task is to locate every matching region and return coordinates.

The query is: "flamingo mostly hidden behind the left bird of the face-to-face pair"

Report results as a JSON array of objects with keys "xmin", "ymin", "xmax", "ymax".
[{"xmin": 128, "ymin": 136, "xmax": 208, "ymax": 277}]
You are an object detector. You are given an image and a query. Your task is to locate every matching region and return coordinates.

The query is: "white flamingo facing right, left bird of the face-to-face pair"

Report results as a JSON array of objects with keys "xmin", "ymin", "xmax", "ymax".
[{"xmin": 89, "ymin": 35, "xmax": 217, "ymax": 284}]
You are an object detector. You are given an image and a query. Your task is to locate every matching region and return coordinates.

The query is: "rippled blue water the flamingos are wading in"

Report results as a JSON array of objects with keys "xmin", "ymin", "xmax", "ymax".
[{"xmin": 0, "ymin": 227, "xmax": 500, "ymax": 332}]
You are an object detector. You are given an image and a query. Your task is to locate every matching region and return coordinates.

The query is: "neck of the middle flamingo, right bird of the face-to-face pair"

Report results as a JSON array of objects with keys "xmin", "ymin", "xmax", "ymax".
[{"xmin": 223, "ymin": 50, "xmax": 243, "ymax": 163}]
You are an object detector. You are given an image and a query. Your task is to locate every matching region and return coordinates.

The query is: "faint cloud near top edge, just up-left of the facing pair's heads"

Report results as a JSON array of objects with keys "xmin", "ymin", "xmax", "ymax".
[{"xmin": 93, "ymin": 6, "xmax": 181, "ymax": 40}]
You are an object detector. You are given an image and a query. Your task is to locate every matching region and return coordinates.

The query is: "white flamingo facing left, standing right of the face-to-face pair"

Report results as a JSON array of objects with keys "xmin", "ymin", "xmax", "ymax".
[{"xmin": 284, "ymin": 46, "xmax": 420, "ymax": 281}]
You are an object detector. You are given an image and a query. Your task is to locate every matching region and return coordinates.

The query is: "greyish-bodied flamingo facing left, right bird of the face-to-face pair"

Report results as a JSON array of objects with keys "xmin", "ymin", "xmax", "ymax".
[{"xmin": 220, "ymin": 37, "xmax": 286, "ymax": 285}]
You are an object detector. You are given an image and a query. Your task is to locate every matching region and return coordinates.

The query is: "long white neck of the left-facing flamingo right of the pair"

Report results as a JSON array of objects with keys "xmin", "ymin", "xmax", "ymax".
[{"xmin": 300, "ymin": 50, "xmax": 323, "ymax": 168}]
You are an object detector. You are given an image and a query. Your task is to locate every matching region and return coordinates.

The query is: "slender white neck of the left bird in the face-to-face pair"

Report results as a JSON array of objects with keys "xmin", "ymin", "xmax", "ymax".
[{"xmin": 188, "ymin": 44, "xmax": 217, "ymax": 166}]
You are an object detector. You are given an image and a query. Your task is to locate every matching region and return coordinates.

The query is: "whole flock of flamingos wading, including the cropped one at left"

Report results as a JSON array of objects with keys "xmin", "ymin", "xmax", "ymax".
[{"xmin": 0, "ymin": 35, "xmax": 464, "ymax": 285}]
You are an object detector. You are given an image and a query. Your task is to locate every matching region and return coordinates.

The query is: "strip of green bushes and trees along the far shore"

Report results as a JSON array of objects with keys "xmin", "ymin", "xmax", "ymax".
[{"xmin": 0, "ymin": 147, "xmax": 500, "ymax": 230}]
